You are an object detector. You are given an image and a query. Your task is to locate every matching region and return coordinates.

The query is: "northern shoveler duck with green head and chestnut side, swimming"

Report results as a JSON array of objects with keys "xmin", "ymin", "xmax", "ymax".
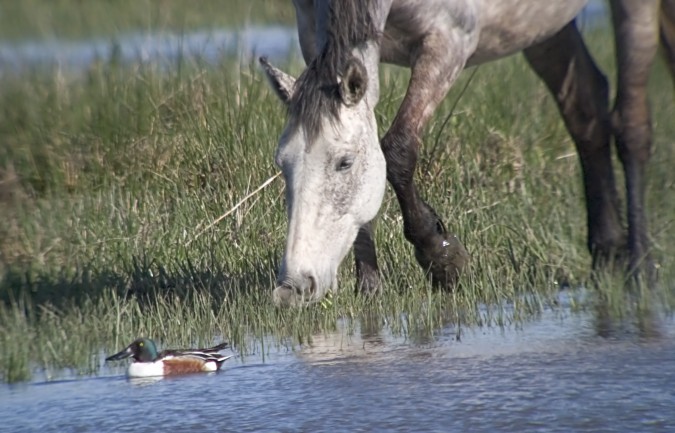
[{"xmin": 106, "ymin": 338, "xmax": 232, "ymax": 377}]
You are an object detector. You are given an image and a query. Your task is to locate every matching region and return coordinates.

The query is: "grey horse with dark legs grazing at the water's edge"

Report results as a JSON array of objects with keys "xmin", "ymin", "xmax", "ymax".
[{"xmin": 261, "ymin": 0, "xmax": 675, "ymax": 305}]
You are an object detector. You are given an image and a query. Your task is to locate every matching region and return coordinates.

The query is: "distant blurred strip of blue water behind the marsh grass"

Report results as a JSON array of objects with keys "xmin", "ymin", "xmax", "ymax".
[{"xmin": 0, "ymin": 0, "xmax": 607, "ymax": 73}]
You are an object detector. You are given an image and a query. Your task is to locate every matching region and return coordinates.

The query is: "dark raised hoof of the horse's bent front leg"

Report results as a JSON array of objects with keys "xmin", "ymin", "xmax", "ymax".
[{"xmin": 415, "ymin": 234, "xmax": 469, "ymax": 289}]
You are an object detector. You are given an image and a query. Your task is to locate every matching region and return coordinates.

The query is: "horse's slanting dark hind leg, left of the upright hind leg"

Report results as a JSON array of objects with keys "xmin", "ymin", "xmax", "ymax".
[{"xmin": 524, "ymin": 23, "xmax": 626, "ymax": 268}]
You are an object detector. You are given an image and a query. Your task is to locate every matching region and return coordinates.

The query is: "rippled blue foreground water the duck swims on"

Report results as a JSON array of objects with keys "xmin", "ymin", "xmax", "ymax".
[{"xmin": 0, "ymin": 304, "xmax": 675, "ymax": 432}]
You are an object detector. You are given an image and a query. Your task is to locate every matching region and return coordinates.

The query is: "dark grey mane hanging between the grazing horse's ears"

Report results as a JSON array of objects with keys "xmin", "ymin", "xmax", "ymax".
[{"xmin": 289, "ymin": 0, "xmax": 377, "ymax": 142}]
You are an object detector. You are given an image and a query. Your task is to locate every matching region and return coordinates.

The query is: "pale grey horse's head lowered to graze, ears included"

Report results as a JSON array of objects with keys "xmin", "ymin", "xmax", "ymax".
[{"xmin": 261, "ymin": 57, "xmax": 386, "ymax": 305}]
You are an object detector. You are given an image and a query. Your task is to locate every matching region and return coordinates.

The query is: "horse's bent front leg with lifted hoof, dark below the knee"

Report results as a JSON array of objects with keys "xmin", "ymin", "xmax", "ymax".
[{"xmin": 382, "ymin": 34, "xmax": 468, "ymax": 287}]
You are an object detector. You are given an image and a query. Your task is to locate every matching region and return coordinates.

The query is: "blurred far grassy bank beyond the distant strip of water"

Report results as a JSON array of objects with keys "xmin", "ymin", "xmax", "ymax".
[{"xmin": 0, "ymin": 0, "xmax": 295, "ymax": 42}]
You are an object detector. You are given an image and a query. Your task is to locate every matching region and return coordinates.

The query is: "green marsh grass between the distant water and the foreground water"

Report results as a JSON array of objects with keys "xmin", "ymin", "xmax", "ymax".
[{"xmin": 0, "ymin": 24, "xmax": 675, "ymax": 382}]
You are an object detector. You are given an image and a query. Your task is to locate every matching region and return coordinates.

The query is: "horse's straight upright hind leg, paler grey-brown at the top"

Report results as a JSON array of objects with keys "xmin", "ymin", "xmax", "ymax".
[{"xmin": 611, "ymin": 0, "xmax": 659, "ymax": 277}]
